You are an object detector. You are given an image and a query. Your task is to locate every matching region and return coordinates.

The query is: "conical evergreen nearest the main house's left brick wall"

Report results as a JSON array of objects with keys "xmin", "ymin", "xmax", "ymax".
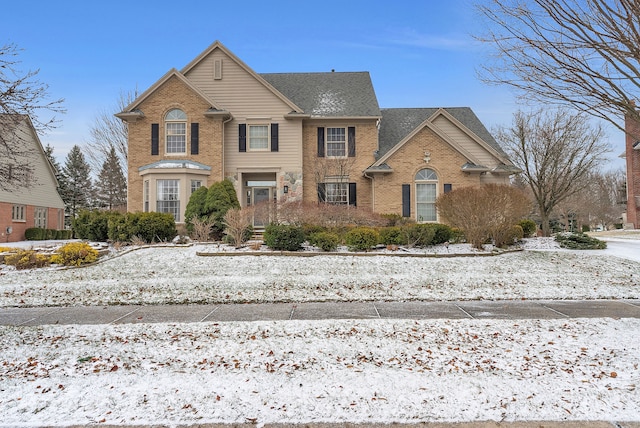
[{"xmin": 96, "ymin": 146, "xmax": 127, "ymax": 210}]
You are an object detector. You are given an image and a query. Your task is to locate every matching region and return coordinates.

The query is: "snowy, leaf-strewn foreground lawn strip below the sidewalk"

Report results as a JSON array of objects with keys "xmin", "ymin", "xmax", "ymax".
[{"xmin": 0, "ymin": 319, "xmax": 640, "ymax": 427}]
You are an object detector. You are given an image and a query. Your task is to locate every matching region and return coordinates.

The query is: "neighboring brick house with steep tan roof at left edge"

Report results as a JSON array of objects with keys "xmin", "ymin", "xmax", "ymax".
[{"xmin": 0, "ymin": 115, "xmax": 64, "ymax": 244}]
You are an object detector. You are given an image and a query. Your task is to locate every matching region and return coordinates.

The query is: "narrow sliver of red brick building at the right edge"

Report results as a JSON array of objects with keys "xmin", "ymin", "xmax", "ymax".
[{"xmin": 624, "ymin": 112, "xmax": 640, "ymax": 229}]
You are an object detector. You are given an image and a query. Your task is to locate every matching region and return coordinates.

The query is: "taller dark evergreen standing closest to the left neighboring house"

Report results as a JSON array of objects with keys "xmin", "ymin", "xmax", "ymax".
[{"xmin": 60, "ymin": 145, "xmax": 94, "ymax": 224}]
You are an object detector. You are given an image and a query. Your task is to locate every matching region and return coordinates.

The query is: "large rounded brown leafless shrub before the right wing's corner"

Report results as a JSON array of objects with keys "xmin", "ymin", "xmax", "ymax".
[{"xmin": 436, "ymin": 184, "xmax": 531, "ymax": 249}]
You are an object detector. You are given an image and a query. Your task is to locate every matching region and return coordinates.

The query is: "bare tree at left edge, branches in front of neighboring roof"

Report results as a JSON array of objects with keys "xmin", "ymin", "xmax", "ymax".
[{"xmin": 0, "ymin": 44, "xmax": 64, "ymax": 190}]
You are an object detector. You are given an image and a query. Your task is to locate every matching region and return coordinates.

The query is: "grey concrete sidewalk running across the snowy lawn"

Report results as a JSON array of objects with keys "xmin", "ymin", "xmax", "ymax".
[{"xmin": 0, "ymin": 300, "xmax": 640, "ymax": 326}]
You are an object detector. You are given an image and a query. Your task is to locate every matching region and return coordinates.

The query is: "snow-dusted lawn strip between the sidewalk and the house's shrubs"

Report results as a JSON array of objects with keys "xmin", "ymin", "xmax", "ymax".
[{"xmin": 0, "ymin": 240, "xmax": 640, "ymax": 307}]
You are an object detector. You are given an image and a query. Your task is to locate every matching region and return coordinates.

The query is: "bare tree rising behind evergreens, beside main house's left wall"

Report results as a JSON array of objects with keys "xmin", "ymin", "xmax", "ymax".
[{"xmin": 86, "ymin": 91, "xmax": 137, "ymax": 177}]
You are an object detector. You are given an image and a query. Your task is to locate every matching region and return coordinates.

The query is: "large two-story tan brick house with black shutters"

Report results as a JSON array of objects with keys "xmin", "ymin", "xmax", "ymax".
[{"xmin": 116, "ymin": 42, "xmax": 518, "ymax": 226}]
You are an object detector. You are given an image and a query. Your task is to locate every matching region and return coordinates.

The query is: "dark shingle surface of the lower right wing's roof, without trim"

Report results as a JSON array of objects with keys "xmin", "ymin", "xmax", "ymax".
[{"xmin": 379, "ymin": 107, "xmax": 507, "ymax": 157}]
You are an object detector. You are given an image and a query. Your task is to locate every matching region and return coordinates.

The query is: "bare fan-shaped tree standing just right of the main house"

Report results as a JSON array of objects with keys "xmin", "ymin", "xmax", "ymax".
[{"xmin": 496, "ymin": 109, "xmax": 610, "ymax": 236}]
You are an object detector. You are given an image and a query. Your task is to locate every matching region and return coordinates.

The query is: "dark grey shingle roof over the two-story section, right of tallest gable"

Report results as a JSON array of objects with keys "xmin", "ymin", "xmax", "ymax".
[{"xmin": 260, "ymin": 72, "xmax": 381, "ymax": 117}]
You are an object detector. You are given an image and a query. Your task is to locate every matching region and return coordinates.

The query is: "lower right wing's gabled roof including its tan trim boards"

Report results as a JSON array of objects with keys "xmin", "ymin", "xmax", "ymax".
[{"xmin": 374, "ymin": 107, "xmax": 511, "ymax": 165}]
